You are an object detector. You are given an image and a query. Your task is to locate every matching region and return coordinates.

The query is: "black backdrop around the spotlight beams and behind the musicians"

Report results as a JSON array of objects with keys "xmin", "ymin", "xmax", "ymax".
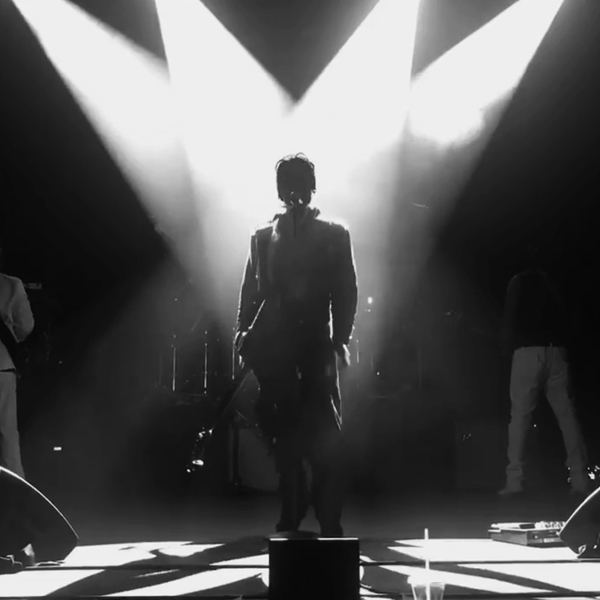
[{"xmin": 0, "ymin": 0, "xmax": 600, "ymax": 490}]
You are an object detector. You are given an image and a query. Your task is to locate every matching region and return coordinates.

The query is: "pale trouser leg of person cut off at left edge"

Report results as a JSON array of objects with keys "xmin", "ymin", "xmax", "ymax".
[{"xmin": 0, "ymin": 371, "xmax": 25, "ymax": 478}]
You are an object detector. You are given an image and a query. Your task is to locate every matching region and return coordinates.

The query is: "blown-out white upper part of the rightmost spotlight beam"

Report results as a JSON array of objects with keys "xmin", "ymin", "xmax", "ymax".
[{"xmin": 409, "ymin": 0, "xmax": 563, "ymax": 147}]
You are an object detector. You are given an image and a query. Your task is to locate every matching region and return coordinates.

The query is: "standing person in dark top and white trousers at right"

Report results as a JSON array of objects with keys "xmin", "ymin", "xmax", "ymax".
[{"xmin": 500, "ymin": 248, "xmax": 590, "ymax": 496}]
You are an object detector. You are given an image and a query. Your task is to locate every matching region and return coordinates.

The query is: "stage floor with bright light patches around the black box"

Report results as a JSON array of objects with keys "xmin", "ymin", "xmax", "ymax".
[{"xmin": 0, "ymin": 494, "xmax": 600, "ymax": 598}]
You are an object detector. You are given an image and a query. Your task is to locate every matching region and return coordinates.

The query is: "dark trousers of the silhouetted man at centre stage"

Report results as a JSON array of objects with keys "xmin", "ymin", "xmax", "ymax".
[{"xmin": 256, "ymin": 344, "xmax": 344, "ymax": 535}]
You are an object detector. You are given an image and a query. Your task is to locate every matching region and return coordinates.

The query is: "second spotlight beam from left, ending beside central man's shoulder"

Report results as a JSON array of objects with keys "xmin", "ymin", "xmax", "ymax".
[{"xmin": 156, "ymin": 0, "xmax": 291, "ymax": 325}]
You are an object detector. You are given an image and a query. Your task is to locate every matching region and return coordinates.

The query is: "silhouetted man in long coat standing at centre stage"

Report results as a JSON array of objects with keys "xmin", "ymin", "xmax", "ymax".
[{"xmin": 236, "ymin": 155, "xmax": 358, "ymax": 536}]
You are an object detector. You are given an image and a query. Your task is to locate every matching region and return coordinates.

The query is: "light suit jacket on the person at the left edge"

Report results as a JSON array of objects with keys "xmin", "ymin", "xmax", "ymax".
[{"xmin": 0, "ymin": 273, "xmax": 34, "ymax": 371}]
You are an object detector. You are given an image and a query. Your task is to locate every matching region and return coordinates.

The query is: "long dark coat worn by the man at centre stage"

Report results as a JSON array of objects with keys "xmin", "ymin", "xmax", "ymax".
[{"xmin": 236, "ymin": 207, "xmax": 358, "ymax": 427}]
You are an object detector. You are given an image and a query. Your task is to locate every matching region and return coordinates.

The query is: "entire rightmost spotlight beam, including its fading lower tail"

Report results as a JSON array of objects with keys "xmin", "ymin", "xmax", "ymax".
[{"xmin": 390, "ymin": 0, "xmax": 563, "ymax": 318}]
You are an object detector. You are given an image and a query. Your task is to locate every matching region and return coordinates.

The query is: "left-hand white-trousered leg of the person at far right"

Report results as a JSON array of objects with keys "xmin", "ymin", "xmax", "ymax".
[{"xmin": 500, "ymin": 347, "xmax": 544, "ymax": 495}]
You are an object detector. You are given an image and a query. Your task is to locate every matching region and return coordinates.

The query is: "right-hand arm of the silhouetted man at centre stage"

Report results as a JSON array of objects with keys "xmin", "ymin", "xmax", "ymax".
[{"xmin": 331, "ymin": 228, "xmax": 358, "ymax": 362}]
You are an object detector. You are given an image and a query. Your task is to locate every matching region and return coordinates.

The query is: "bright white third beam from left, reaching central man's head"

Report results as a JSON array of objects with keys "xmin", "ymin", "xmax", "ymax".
[{"xmin": 280, "ymin": 0, "xmax": 419, "ymax": 223}]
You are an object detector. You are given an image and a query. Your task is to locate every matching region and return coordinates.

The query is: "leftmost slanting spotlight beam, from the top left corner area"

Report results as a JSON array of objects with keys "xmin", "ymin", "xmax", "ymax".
[{"xmin": 14, "ymin": 0, "xmax": 206, "ymax": 282}]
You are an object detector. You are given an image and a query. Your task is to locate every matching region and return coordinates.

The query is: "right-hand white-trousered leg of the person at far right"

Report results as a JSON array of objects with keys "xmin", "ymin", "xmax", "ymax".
[{"xmin": 546, "ymin": 347, "xmax": 590, "ymax": 494}]
